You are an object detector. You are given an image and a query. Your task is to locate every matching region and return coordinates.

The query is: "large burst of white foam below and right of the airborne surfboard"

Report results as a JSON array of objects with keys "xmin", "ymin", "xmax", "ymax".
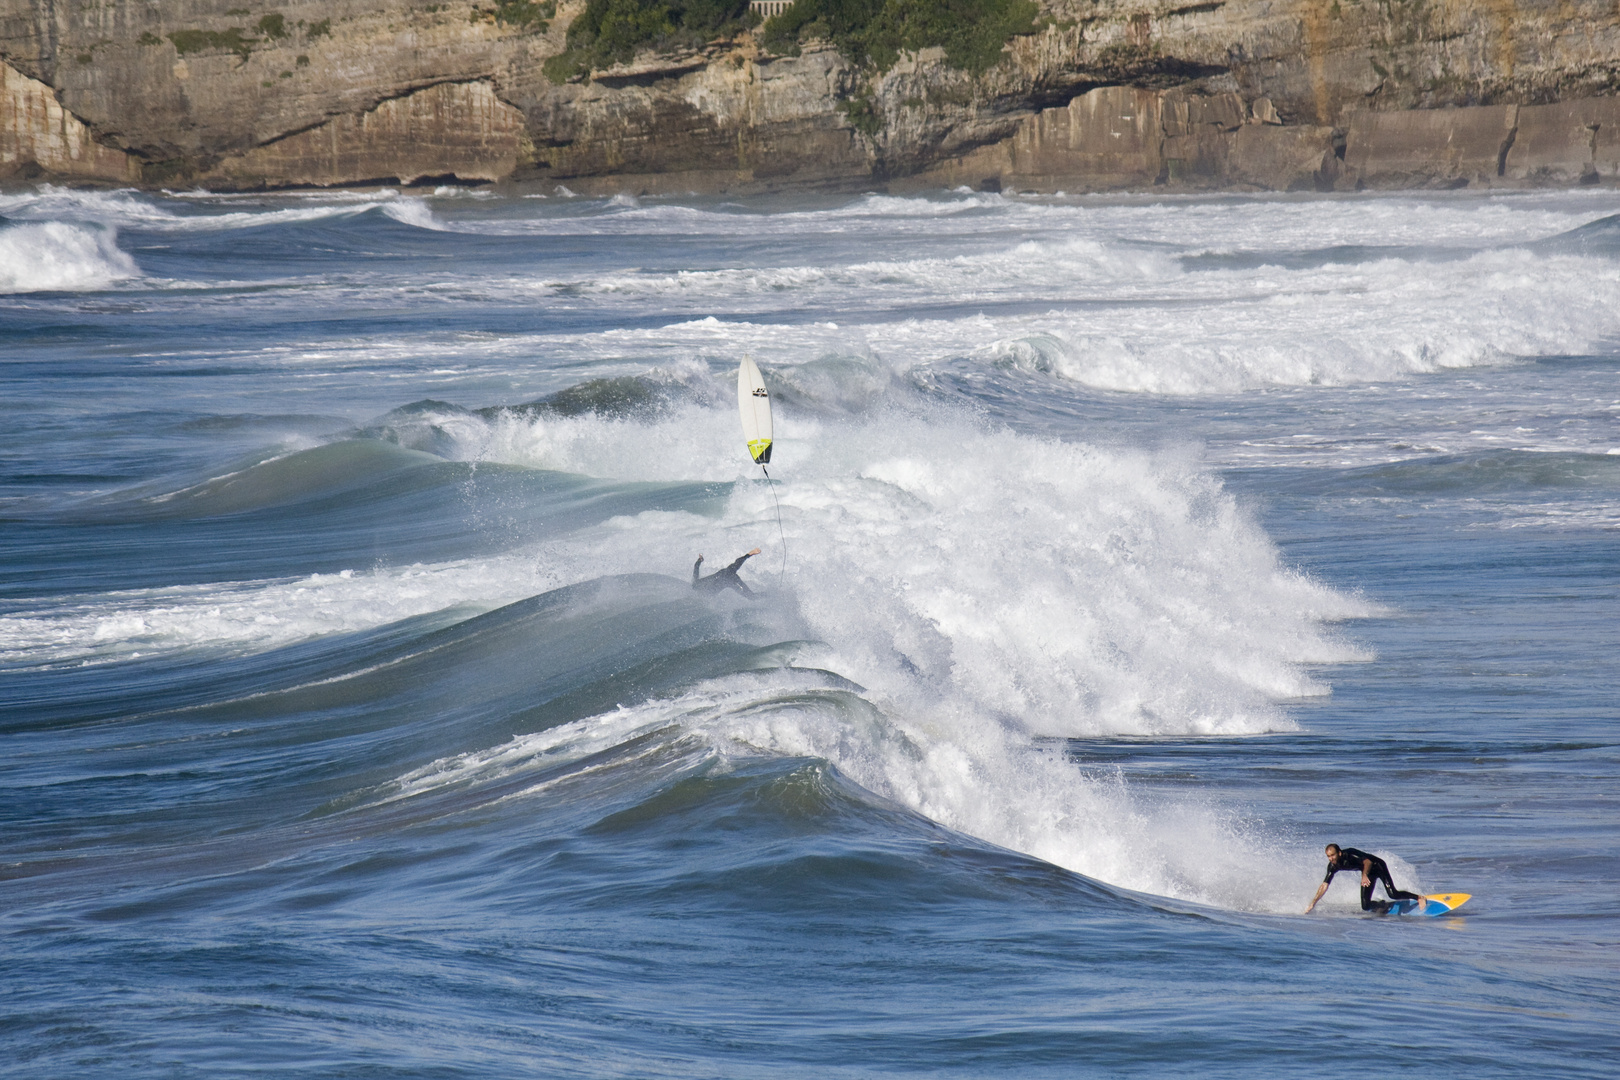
[{"xmin": 476, "ymin": 410, "xmax": 1367, "ymax": 735}]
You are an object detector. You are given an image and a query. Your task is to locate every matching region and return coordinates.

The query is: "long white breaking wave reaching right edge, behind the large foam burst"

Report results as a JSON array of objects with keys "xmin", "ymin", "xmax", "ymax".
[{"xmin": 974, "ymin": 251, "xmax": 1620, "ymax": 395}]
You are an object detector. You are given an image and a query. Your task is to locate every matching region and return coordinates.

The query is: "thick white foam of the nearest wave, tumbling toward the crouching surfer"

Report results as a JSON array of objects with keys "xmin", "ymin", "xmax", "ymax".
[{"xmin": 680, "ymin": 683, "xmax": 1393, "ymax": 913}]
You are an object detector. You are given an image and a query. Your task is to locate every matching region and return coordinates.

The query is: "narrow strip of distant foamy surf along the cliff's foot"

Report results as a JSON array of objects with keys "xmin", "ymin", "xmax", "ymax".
[{"xmin": 15, "ymin": 185, "xmax": 1610, "ymax": 261}]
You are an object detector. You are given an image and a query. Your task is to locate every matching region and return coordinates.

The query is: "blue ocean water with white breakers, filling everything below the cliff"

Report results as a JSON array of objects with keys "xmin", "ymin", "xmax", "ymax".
[{"xmin": 0, "ymin": 186, "xmax": 1620, "ymax": 1078}]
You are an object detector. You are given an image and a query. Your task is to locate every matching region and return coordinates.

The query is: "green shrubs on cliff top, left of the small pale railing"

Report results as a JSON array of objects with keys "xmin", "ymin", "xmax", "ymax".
[{"xmin": 546, "ymin": 0, "xmax": 757, "ymax": 83}]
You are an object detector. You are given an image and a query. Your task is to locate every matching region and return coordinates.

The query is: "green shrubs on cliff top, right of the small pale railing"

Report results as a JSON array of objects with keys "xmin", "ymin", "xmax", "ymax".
[{"xmin": 765, "ymin": 0, "xmax": 1040, "ymax": 74}]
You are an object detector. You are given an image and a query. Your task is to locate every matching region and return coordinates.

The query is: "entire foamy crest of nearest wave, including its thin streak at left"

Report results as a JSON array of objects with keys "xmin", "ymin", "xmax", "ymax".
[{"xmin": 371, "ymin": 670, "xmax": 1393, "ymax": 913}]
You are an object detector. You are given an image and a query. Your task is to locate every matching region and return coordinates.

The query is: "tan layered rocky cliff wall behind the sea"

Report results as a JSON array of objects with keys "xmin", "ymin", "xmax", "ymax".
[{"xmin": 0, "ymin": 0, "xmax": 1620, "ymax": 191}]
